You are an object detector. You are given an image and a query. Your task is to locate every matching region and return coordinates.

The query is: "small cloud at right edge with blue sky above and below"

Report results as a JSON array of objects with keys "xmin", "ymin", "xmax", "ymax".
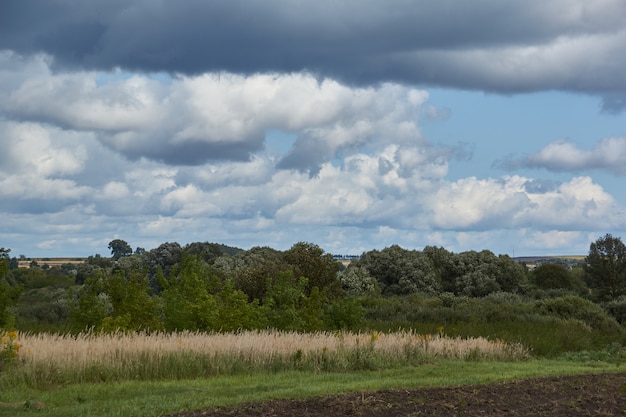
[{"xmin": 495, "ymin": 137, "xmax": 626, "ymax": 175}]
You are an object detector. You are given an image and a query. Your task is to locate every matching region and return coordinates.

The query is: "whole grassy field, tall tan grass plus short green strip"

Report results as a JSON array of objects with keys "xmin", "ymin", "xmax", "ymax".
[{"xmin": 0, "ymin": 330, "xmax": 622, "ymax": 416}]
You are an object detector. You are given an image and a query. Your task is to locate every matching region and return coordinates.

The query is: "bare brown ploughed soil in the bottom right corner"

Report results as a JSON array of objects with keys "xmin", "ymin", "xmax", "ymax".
[{"xmin": 163, "ymin": 373, "xmax": 626, "ymax": 417}]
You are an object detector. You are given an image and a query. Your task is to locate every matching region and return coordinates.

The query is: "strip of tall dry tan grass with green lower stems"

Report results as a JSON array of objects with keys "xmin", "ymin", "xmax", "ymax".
[{"xmin": 0, "ymin": 330, "xmax": 529, "ymax": 387}]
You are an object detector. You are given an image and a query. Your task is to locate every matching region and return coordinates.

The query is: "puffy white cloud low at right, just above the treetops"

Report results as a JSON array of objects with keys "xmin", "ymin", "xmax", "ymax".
[{"xmin": 427, "ymin": 176, "xmax": 626, "ymax": 231}]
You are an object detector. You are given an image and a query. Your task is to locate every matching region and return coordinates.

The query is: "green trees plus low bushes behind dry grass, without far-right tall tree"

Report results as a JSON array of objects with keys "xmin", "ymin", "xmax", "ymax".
[{"xmin": 7, "ymin": 236, "xmax": 626, "ymax": 355}]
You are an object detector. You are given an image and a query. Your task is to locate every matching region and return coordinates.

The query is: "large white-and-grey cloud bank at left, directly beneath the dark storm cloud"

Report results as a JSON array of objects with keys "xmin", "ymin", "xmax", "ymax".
[{"xmin": 0, "ymin": 54, "xmax": 428, "ymax": 168}]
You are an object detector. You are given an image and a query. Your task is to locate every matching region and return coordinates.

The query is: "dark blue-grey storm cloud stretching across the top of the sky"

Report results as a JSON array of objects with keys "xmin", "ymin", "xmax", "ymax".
[{"xmin": 0, "ymin": 0, "xmax": 626, "ymax": 103}]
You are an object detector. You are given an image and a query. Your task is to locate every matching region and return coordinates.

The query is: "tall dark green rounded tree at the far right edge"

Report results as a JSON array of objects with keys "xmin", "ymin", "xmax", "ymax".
[{"xmin": 585, "ymin": 233, "xmax": 626, "ymax": 300}]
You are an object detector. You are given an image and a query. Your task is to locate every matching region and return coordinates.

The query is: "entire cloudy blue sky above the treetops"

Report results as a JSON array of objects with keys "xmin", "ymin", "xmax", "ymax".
[{"xmin": 0, "ymin": 0, "xmax": 626, "ymax": 257}]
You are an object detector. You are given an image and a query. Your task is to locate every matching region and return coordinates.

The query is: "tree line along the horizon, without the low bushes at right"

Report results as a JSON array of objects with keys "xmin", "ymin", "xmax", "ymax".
[{"xmin": 0, "ymin": 234, "xmax": 626, "ymax": 332}]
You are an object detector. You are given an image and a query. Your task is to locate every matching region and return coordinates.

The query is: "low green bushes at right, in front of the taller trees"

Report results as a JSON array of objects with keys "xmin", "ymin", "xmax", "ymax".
[{"xmin": 362, "ymin": 293, "xmax": 626, "ymax": 356}]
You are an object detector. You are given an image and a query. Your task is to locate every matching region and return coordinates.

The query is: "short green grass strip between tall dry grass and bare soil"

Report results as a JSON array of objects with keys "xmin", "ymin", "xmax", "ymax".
[{"xmin": 0, "ymin": 359, "xmax": 626, "ymax": 417}]
